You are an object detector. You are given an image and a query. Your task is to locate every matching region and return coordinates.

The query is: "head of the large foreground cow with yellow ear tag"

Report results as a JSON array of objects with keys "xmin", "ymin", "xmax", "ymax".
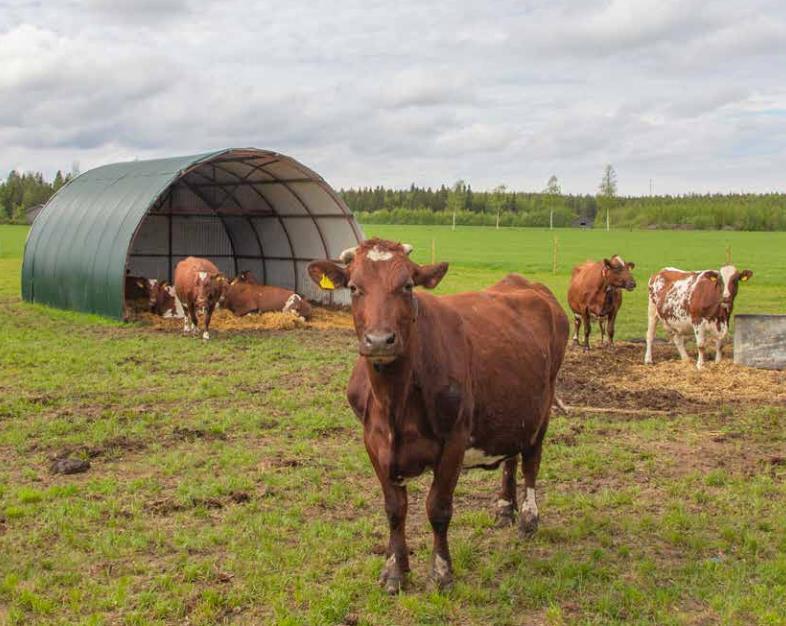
[{"xmin": 308, "ymin": 238, "xmax": 448, "ymax": 364}]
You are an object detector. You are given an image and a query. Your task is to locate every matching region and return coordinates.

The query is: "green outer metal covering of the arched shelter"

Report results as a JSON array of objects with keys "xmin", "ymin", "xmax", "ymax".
[{"xmin": 22, "ymin": 150, "xmax": 239, "ymax": 319}]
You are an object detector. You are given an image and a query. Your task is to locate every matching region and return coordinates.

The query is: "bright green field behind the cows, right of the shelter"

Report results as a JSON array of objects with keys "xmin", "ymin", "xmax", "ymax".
[{"xmin": 364, "ymin": 224, "xmax": 786, "ymax": 340}]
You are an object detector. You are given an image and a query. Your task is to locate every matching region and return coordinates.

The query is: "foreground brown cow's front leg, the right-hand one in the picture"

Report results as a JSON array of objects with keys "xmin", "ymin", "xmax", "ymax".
[{"xmin": 426, "ymin": 435, "xmax": 466, "ymax": 590}]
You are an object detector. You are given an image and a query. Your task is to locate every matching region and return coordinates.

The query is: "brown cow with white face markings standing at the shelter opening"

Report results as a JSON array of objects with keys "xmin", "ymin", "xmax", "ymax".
[{"xmin": 175, "ymin": 256, "xmax": 229, "ymax": 339}]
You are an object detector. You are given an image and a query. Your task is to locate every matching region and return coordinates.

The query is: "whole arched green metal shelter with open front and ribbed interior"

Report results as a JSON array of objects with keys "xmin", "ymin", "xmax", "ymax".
[{"xmin": 22, "ymin": 148, "xmax": 363, "ymax": 319}]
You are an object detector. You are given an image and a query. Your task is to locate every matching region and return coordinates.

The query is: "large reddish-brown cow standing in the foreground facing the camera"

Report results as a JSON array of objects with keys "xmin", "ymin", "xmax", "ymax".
[{"xmin": 308, "ymin": 239, "xmax": 569, "ymax": 593}]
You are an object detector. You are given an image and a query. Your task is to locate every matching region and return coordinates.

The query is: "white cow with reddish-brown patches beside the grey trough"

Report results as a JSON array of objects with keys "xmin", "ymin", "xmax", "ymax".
[{"xmin": 644, "ymin": 265, "xmax": 753, "ymax": 369}]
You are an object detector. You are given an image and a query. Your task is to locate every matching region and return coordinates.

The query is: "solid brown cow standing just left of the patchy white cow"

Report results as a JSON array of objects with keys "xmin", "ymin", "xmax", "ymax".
[{"xmin": 568, "ymin": 254, "xmax": 636, "ymax": 350}]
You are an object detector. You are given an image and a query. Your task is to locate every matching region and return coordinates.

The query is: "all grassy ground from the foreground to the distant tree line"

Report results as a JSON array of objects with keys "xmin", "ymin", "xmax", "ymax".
[{"xmin": 0, "ymin": 222, "xmax": 786, "ymax": 626}]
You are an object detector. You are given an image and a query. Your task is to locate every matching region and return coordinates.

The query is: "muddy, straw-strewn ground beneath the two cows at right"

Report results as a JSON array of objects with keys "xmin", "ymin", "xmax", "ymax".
[{"xmin": 557, "ymin": 342, "xmax": 786, "ymax": 413}]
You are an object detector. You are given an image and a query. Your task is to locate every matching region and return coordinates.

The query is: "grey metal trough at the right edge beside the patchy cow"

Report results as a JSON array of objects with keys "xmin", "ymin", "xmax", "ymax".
[{"xmin": 734, "ymin": 315, "xmax": 786, "ymax": 370}]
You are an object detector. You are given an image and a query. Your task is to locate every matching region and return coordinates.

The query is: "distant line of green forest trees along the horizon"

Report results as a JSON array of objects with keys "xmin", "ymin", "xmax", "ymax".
[{"xmin": 0, "ymin": 165, "xmax": 786, "ymax": 230}]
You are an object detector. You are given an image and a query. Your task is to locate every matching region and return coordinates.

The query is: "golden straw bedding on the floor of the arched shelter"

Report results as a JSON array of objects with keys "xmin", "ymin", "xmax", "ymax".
[{"xmin": 129, "ymin": 306, "xmax": 353, "ymax": 332}]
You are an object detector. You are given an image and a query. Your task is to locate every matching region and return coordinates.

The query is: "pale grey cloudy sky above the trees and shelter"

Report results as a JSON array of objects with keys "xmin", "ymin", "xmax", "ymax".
[{"xmin": 0, "ymin": 0, "xmax": 786, "ymax": 194}]
